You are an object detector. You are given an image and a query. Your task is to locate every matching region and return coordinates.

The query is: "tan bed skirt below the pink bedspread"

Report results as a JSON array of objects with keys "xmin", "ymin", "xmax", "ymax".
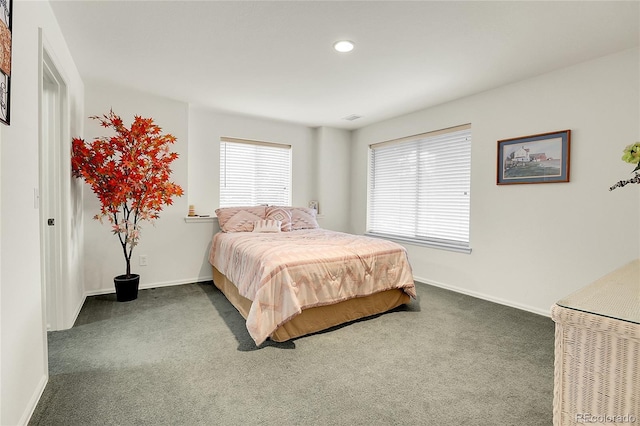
[{"xmin": 212, "ymin": 267, "xmax": 411, "ymax": 342}]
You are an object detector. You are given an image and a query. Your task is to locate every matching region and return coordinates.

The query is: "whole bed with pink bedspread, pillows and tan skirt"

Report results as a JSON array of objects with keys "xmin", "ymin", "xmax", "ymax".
[{"xmin": 209, "ymin": 206, "xmax": 416, "ymax": 345}]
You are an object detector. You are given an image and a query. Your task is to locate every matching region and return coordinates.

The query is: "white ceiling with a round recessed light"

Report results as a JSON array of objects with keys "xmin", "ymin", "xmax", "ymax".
[{"xmin": 51, "ymin": 0, "xmax": 640, "ymax": 129}]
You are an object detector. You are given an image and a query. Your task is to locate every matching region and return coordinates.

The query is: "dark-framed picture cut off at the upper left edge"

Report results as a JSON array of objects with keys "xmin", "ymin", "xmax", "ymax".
[{"xmin": 0, "ymin": 0, "xmax": 13, "ymax": 125}]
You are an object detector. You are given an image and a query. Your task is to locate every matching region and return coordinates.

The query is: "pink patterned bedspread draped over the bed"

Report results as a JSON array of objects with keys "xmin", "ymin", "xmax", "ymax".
[{"xmin": 209, "ymin": 229, "xmax": 416, "ymax": 345}]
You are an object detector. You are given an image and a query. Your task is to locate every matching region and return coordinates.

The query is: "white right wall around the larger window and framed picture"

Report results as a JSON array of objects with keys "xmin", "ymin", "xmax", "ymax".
[{"xmin": 351, "ymin": 50, "xmax": 640, "ymax": 314}]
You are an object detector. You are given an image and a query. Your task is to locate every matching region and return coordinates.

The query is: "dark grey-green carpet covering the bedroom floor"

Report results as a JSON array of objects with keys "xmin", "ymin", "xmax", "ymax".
[{"xmin": 29, "ymin": 284, "xmax": 554, "ymax": 426}]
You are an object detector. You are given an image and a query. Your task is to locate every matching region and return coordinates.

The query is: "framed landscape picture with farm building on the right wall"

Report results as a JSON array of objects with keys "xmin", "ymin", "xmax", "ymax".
[{"xmin": 496, "ymin": 130, "xmax": 571, "ymax": 185}]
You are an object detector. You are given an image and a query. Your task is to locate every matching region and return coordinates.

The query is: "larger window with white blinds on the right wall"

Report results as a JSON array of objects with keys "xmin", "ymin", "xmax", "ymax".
[{"xmin": 367, "ymin": 125, "xmax": 471, "ymax": 252}]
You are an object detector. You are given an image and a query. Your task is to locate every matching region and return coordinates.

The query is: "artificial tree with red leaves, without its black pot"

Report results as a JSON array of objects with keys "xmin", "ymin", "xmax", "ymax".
[{"xmin": 71, "ymin": 110, "xmax": 183, "ymax": 278}]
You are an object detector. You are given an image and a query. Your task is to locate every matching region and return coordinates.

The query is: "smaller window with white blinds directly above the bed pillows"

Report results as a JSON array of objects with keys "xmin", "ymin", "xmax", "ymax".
[{"xmin": 220, "ymin": 138, "xmax": 291, "ymax": 207}]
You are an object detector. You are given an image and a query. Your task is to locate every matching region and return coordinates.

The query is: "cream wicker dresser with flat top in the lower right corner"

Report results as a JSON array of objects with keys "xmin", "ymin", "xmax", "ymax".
[{"xmin": 551, "ymin": 259, "xmax": 640, "ymax": 426}]
